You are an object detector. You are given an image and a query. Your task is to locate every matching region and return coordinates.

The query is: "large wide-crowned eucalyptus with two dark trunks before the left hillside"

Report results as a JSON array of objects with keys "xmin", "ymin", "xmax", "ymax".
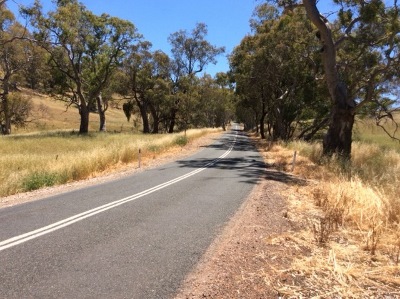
[{"xmin": 24, "ymin": 0, "xmax": 140, "ymax": 133}]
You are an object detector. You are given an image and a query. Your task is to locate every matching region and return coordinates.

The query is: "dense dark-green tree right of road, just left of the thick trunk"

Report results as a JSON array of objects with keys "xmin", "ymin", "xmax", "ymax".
[{"xmin": 230, "ymin": 5, "xmax": 316, "ymax": 140}]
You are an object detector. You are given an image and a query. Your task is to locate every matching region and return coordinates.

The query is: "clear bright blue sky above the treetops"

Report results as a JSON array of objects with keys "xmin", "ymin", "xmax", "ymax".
[{"xmin": 7, "ymin": 0, "xmax": 262, "ymax": 75}]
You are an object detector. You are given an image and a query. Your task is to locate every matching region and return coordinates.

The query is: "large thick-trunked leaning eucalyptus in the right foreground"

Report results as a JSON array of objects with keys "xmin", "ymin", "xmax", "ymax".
[{"xmin": 278, "ymin": 0, "xmax": 400, "ymax": 159}]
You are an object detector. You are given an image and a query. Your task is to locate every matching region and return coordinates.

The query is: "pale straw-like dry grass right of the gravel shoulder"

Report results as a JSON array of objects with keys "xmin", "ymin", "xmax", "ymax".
[{"xmin": 253, "ymin": 137, "xmax": 400, "ymax": 298}]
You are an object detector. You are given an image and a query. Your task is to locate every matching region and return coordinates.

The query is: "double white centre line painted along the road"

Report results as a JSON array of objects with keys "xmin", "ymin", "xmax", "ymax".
[{"xmin": 0, "ymin": 132, "xmax": 237, "ymax": 251}]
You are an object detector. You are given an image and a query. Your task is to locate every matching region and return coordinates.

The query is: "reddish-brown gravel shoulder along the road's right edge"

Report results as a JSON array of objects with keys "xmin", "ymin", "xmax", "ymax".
[{"xmin": 175, "ymin": 179, "xmax": 302, "ymax": 299}]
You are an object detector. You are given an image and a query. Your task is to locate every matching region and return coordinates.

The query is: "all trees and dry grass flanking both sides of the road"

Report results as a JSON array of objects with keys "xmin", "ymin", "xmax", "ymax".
[{"xmin": 0, "ymin": 0, "xmax": 400, "ymax": 298}]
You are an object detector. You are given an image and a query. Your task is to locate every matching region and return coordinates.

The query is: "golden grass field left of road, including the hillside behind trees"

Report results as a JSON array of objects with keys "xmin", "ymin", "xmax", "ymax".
[{"xmin": 0, "ymin": 91, "xmax": 217, "ymax": 197}]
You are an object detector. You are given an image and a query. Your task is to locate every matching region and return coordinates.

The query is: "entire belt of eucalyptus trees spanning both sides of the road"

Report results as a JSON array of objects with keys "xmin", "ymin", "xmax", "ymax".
[{"xmin": 0, "ymin": 0, "xmax": 400, "ymax": 155}]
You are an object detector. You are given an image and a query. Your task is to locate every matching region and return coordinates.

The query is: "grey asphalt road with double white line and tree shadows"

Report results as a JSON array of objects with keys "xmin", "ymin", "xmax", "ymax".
[{"xmin": 0, "ymin": 130, "xmax": 265, "ymax": 299}]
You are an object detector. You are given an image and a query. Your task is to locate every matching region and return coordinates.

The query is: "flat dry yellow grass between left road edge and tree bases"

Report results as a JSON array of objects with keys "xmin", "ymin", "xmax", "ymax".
[{"xmin": 0, "ymin": 129, "xmax": 217, "ymax": 196}]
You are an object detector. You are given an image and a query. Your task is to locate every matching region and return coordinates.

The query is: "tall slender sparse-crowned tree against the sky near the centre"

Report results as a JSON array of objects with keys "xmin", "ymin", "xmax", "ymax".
[{"xmin": 168, "ymin": 23, "xmax": 225, "ymax": 133}]
